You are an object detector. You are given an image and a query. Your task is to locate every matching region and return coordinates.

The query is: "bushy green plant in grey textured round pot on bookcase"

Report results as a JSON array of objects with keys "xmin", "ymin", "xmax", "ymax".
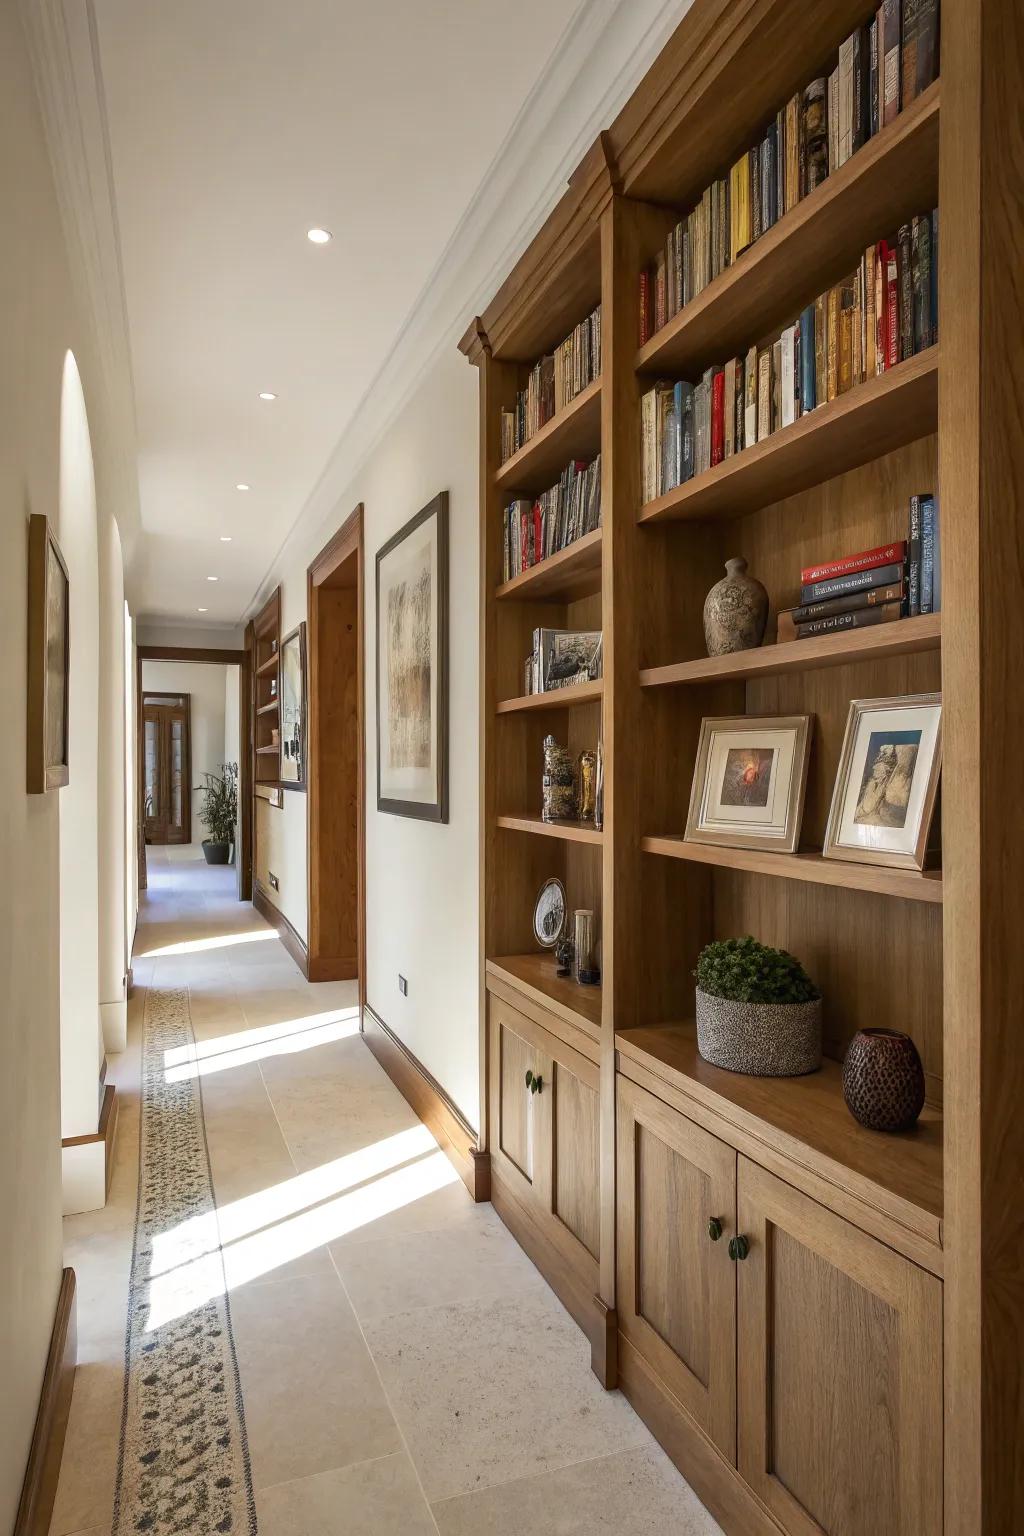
[{"xmin": 694, "ymin": 937, "xmax": 821, "ymax": 1077}]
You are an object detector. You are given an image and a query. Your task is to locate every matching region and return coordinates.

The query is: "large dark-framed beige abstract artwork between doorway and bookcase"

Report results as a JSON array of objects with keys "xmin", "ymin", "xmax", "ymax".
[{"xmin": 375, "ymin": 492, "xmax": 448, "ymax": 823}]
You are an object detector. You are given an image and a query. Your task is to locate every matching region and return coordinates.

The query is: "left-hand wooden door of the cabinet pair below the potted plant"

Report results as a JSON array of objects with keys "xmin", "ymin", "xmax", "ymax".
[{"xmin": 617, "ymin": 1077, "xmax": 737, "ymax": 1459}]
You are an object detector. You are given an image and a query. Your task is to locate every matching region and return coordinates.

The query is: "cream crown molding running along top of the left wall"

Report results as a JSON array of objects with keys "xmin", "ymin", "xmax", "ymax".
[{"xmin": 20, "ymin": 0, "xmax": 141, "ymax": 570}]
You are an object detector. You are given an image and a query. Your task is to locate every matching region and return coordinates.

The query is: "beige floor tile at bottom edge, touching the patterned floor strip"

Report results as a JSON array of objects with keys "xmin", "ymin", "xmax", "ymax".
[{"xmin": 256, "ymin": 1452, "xmax": 438, "ymax": 1536}]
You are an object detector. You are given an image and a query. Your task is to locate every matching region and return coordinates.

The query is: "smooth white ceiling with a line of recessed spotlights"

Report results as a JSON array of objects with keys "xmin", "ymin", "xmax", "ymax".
[{"xmin": 95, "ymin": 0, "xmax": 583, "ymax": 624}]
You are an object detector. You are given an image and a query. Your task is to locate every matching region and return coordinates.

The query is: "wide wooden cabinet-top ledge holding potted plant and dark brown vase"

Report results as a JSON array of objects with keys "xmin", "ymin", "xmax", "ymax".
[{"xmin": 616, "ymin": 1023, "xmax": 943, "ymax": 1272}]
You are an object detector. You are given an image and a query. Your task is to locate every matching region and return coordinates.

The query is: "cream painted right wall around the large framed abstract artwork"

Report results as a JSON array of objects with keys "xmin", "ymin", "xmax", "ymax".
[{"xmin": 256, "ymin": 346, "xmax": 479, "ymax": 1124}]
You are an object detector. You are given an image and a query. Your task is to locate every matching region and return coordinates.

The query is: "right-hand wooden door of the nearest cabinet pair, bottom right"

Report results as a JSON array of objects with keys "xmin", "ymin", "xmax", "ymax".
[{"xmin": 735, "ymin": 1157, "xmax": 943, "ymax": 1536}]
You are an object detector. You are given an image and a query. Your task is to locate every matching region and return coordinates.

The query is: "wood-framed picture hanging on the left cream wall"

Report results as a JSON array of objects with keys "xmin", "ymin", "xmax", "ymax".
[{"xmin": 26, "ymin": 513, "xmax": 71, "ymax": 794}]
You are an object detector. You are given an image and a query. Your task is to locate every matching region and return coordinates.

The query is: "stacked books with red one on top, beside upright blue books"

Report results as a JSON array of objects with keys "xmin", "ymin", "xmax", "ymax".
[{"xmin": 778, "ymin": 492, "xmax": 943, "ymax": 642}]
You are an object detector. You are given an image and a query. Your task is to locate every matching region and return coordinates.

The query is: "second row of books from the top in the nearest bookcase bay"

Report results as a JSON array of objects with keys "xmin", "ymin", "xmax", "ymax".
[{"xmin": 640, "ymin": 209, "xmax": 938, "ymax": 502}]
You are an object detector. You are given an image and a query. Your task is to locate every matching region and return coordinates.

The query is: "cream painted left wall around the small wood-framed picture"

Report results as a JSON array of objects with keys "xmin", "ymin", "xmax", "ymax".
[{"xmin": 0, "ymin": 5, "xmax": 138, "ymax": 1531}]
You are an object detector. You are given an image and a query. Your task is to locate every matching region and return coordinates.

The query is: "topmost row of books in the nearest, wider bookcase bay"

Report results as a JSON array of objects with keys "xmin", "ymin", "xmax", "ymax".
[{"xmin": 640, "ymin": 0, "xmax": 938, "ymax": 346}]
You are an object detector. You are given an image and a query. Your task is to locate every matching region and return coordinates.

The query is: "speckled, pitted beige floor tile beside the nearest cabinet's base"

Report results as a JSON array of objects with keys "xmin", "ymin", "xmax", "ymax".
[{"xmin": 364, "ymin": 1286, "xmax": 651, "ymax": 1502}]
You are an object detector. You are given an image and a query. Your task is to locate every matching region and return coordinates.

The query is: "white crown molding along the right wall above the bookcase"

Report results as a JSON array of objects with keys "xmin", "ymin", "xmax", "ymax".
[{"xmin": 246, "ymin": 0, "xmax": 692, "ymax": 617}]
